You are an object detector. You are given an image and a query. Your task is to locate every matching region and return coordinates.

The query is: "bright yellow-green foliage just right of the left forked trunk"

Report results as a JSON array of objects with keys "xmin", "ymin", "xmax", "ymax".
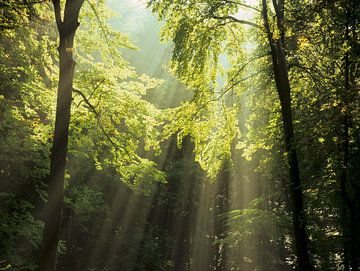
[{"xmin": 70, "ymin": 1, "xmax": 164, "ymax": 193}]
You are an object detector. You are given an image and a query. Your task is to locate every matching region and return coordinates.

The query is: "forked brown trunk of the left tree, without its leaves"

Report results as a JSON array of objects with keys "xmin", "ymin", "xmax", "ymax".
[{"xmin": 39, "ymin": 0, "xmax": 84, "ymax": 271}]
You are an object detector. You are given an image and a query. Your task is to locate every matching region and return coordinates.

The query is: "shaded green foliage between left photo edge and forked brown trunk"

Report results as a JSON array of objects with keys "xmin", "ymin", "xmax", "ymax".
[{"xmin": 0, "ymin": 7, "xmax": 55, "ymax": 270}]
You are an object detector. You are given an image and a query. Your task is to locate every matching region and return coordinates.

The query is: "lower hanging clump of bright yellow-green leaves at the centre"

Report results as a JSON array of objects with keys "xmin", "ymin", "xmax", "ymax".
[{"xmin": 162, "ymin": 99, "xmax": 239, "ymax": 179}]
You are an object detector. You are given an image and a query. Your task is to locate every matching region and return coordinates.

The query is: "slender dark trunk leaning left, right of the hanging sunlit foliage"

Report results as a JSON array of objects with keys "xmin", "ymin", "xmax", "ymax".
[{"xmin": 262, "ymin": 0, "xmax": 314, "ymax": 271}]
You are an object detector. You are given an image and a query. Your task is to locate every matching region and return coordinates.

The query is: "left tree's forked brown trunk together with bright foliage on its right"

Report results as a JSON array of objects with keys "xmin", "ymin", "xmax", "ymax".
[{"xmin": 40, "ymin": 1, "xmax": 164, "ymax": 270}]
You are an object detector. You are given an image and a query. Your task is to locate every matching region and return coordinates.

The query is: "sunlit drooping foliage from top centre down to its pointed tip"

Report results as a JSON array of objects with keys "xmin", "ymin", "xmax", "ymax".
[{"xmin": 149, "ymin": 0, "xmax": 258, "ymax": 177}]
